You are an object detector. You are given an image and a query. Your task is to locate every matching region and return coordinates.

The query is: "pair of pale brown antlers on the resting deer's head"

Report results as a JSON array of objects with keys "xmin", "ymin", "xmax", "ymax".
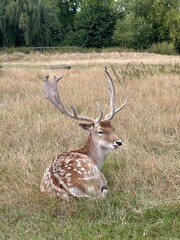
[{"xmin": 44, "ymin": 68, "xmax": 127, "ymax": 123}]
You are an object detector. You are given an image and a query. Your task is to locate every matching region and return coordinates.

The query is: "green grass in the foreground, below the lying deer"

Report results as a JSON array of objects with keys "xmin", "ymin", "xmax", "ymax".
[{"xmin": 0, "ymin": 197, "xmax": 180, "ymax": 240}]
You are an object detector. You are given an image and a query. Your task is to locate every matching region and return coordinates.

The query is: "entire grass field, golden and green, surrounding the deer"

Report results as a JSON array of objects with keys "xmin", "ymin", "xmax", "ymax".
[{"xmin": 0, "ymin": 53, "xmax": 180, "ymax": 240}]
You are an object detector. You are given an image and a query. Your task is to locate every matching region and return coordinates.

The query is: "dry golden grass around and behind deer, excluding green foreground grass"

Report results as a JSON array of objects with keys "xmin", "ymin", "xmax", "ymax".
[{"xmin": 0, "ymin": 53, "xmax": 180, "ymax": 208}]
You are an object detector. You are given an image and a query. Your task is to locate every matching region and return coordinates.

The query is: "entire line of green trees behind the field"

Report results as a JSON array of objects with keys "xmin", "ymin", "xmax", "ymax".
[{"xmin": 0, "ymin": 0, "xmax": 180, "ymax": 51}]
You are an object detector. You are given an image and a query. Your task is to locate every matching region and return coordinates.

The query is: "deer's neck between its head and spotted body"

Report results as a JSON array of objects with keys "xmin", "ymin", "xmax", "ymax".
[{"xmin": 78, "ymin": 133, "xmax": 109, "ymax": 169}]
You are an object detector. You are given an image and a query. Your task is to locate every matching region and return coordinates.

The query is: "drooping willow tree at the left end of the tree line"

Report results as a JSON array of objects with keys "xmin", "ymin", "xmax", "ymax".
[{"xmin": 0, "ymin": 0, "xmax": 59, "ymax": 46}]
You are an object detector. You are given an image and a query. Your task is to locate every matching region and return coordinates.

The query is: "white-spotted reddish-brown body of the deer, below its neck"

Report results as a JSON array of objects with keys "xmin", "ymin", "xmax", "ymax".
[{"xmin": 41, "ymin": 152, "xmax": 106, "ymax": 197}]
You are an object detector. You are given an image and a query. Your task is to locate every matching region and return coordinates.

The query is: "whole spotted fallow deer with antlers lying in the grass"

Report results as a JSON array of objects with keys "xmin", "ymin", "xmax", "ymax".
[{"xmin": 41, "ymin": 68, "xmax": 127, "ymax": 198}]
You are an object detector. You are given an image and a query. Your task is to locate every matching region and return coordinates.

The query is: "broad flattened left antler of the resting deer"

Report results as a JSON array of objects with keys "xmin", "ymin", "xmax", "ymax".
[{"xmin": 44, "ymin": 76, "xmax": 94, "ymax": 122}]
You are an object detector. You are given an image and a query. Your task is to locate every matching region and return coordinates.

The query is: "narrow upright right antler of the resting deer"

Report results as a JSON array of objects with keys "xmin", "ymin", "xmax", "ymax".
[{"xmin": 104, "ymin": 67, "xmax": 128, "ymax": 121}]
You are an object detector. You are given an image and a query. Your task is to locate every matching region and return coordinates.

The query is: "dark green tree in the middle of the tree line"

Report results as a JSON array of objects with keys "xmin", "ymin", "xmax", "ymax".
[{"xmin": 69, "ymin": 0, "xmax": 116, "ymax": 48}]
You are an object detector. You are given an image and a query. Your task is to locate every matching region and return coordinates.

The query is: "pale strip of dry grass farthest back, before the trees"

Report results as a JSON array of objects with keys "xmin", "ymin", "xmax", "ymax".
[{"xmin": 0, "ymin": 52, "xmax": 180, "ymax": 67}]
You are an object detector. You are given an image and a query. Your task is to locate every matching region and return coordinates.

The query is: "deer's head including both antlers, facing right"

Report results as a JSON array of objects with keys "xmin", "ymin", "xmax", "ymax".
[{"xmin": 44, "ymin": 68, "xmax": 127, "ymax": 152}]
